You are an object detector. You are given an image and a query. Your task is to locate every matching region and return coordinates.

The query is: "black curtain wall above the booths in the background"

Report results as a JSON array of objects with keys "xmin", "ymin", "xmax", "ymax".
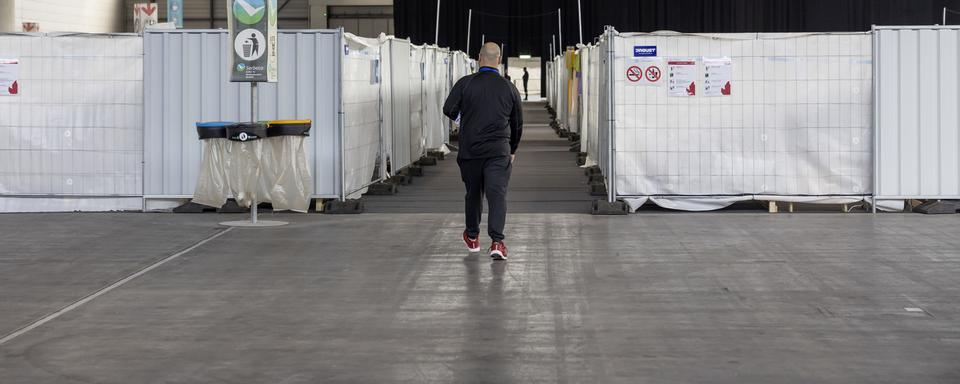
[{"xmin": 393, "ymin": 0, "xmax": 960, "ymax": 56}]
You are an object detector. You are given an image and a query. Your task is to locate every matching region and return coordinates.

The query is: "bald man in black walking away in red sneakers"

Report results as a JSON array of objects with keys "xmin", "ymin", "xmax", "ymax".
[{"xmin": 443, "ymin": 43, "xmax": 523, "ymax": 260}]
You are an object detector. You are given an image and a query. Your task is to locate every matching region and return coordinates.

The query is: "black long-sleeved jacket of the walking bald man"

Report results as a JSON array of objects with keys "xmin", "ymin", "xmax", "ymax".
[{"xmin": 443, "ymin": 67, "xmax": 523, "ymax": 159}]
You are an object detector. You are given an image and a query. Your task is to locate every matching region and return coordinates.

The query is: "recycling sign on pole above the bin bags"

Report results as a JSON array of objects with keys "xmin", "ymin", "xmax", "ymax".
[{"xmin": 227, "ymin": 0, "xmax": 277, "ymax": 83}]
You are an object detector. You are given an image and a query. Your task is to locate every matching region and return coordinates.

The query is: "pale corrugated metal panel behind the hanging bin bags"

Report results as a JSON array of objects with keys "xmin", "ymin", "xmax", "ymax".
[{"xmin": 144, "ymin": 30, "xmax": 341, "ymax": 198}]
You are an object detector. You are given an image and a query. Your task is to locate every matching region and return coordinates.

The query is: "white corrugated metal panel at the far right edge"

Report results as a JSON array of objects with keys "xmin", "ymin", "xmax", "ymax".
[{"xmin": 874, "ymin": 26, "xmax": 960, "ymax": 200}]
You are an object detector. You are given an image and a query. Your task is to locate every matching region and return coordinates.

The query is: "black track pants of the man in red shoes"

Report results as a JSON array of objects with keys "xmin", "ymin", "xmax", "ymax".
[{"xmin": 457, "ymin": 156, "xmax": 512, "ymax": 241}]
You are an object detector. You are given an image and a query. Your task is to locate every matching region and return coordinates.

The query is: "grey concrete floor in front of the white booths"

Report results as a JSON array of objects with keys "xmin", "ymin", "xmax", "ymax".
[{"xmin": 0, "ymin": 213, "xmax": 960, "ymax": 384}]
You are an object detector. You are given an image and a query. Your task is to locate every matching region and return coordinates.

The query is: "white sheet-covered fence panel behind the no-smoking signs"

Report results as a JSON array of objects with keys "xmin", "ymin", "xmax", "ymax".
[{"xmin": 608, "ymin": 33, "xmax": 873, "ymax": 200}]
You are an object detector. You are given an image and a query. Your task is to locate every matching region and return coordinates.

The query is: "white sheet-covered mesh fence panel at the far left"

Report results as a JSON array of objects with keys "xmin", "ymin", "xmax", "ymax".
[{"xmin": 0, "ymin": 33, "xmax": 143, "ymax": 212}]
